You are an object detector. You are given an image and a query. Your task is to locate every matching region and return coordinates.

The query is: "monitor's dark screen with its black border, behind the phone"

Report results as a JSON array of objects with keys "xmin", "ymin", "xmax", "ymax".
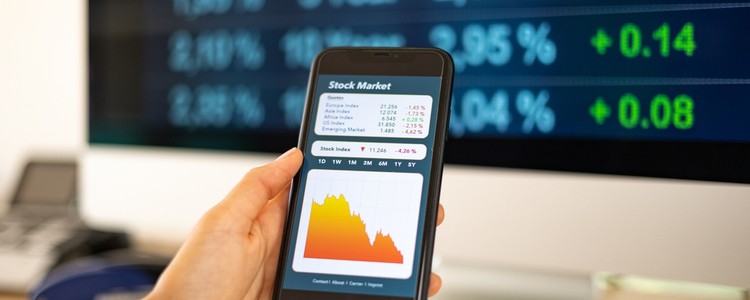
[{"xmin": 89, "ymin": 0, "xmax": 750, "ymax": 183}]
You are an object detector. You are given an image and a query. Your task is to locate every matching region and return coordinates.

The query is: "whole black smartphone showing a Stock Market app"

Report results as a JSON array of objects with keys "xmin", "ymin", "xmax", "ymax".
[{"xmin": 274, "ymin": 48, "xmax": 453, "ymax": 300}]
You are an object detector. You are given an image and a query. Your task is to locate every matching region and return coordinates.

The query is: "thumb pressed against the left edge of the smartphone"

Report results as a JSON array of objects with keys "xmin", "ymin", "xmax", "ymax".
[{"xmin": 221, "ymin": 148, "xmax": 302, "ymax": 225}]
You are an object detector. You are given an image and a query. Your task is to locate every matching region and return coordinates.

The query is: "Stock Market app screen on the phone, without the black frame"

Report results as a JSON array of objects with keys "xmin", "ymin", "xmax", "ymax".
[{"xmin": 283, "ymin": 75, "xmax": 440, "ymax": 297}]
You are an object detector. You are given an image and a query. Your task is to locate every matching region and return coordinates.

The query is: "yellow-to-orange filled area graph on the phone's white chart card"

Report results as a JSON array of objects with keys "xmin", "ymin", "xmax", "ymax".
[{"xmin": 304, "ymin": 195, "xmax": 404, "ymax": 264}]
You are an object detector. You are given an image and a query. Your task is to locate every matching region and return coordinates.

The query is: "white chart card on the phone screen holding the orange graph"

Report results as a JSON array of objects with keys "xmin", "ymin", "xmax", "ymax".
[{"xmin": 292, "ymin": 170, "xmax": 423, "ymax": 278}]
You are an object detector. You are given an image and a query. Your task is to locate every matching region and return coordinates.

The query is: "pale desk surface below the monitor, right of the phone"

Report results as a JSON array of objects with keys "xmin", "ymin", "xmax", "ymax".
[{"xmin": 434, "ymin": 258, "xmax": 750, "ymax": 300}]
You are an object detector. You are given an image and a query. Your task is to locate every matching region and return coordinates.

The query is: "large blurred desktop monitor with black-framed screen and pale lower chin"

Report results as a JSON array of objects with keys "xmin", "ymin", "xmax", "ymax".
[{"xmin": 83, "ymin": 0, "xmax": 750, "ymax": 285}]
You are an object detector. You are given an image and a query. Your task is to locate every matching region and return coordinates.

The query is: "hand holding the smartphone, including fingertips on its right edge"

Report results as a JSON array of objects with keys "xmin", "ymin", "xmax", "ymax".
[{"xmin": 147, "ymin": 148, "xmax": 445, "ymax": 299}]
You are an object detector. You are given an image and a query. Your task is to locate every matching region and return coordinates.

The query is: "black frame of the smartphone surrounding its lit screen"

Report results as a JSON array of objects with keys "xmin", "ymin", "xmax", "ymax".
[{"xmin": 273, "ymin": 47, "xmax": 453, "ymax": 299}]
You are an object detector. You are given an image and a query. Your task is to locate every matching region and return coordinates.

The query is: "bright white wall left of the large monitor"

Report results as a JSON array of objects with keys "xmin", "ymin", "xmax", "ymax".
[{"xmin": 0, "ymin": 0, "xmax": 86, "ymax": 210}]
